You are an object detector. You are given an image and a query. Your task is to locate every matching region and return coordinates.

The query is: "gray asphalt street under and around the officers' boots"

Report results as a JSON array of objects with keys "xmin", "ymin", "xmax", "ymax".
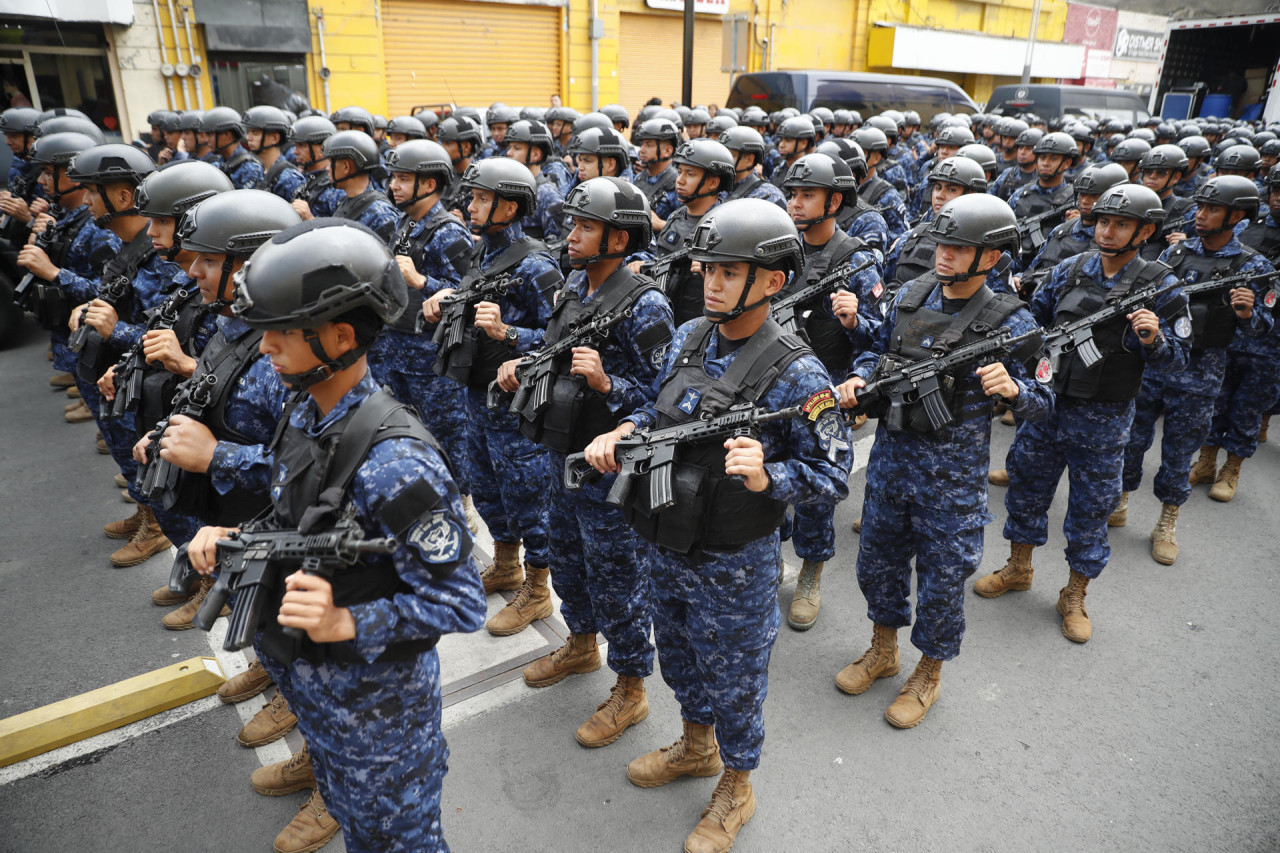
[{"xmin": 0, "ymin": 312, "xmax": 1280, "ymax": 853}]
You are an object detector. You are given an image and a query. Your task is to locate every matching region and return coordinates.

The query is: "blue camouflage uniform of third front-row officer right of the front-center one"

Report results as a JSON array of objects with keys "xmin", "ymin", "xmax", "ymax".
[{"xmin": 1124, "ymin": 237, "xmax": 1274, "ymax": 506}]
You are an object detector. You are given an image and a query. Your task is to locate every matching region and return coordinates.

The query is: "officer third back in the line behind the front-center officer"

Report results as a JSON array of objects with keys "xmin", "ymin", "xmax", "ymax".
[{"xmin": 422, "ymin": 158, "xmax": 564, "ymax": 637}]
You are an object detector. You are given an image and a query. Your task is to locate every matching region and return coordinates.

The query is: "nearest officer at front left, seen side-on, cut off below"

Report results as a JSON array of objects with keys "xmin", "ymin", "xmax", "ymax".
[{"xmin": 191, "ymin": 220, "xmax": 485, "ymax": 853}]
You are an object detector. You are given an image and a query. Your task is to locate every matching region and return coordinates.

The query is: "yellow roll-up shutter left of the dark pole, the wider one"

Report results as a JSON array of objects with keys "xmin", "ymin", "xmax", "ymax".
[{"xmin": 381, "ymin": 0, "xmax": 561, "ymax": 115}]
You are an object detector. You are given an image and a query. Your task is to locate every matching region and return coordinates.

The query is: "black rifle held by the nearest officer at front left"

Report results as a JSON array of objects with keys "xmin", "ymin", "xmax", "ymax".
[{"xmin": 192, "ymin": 520, "xmax": 397, "ymax": 652}]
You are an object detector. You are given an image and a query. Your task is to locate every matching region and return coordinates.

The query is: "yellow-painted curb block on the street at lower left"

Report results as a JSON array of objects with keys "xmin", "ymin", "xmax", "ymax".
[{"xmin": 0, "ymin": 657, "xmax": 227, "ymax": 767}]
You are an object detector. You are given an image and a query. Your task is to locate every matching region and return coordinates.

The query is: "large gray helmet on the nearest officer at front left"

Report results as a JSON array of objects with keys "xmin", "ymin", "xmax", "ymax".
[{"xmin": 232, "ymin": 219, "xmax": 408, "ymax": 389}]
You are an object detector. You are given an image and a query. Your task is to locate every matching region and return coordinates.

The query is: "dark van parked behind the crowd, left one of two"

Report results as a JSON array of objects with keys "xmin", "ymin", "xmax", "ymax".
[{"xmin": 727, "ymin": 70, "xmax": 978, "ymax": 122}]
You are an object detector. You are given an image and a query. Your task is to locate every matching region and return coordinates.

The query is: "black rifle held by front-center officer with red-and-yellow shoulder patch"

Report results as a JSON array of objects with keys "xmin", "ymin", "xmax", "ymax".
[{"xmin": 564, "ymin": 403, "xmax": 805, "ymax": 512}]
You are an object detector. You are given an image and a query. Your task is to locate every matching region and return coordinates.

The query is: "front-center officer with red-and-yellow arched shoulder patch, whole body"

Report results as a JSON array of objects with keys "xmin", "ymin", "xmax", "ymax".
[{"xmin": 586, "ymin": 199, "xmax": 851, "ymax": 853}]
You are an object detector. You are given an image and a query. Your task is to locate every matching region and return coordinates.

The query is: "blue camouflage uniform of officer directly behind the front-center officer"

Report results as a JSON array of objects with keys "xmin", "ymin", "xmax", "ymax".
[{"xmin": 548, "ymin": 272, "xmax": 675, "ymax": 678}]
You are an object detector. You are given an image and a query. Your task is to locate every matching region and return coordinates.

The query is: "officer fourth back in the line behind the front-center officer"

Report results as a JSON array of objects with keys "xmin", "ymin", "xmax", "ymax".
[{"xmin": 369, "ymin": 140, "xmax": 472, "ymax": 515}]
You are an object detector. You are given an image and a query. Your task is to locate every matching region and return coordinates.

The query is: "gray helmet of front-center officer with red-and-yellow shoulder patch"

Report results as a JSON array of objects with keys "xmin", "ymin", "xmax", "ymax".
[{"xmin": 690, "ymin": 199, "xmax": 804, "ymax": 324}]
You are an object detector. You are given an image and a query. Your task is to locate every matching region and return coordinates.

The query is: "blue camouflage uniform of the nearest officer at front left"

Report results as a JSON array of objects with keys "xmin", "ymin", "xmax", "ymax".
[{"xmin": 254, "ymin": 375, "xmax": 485, "ymax": 853}]
